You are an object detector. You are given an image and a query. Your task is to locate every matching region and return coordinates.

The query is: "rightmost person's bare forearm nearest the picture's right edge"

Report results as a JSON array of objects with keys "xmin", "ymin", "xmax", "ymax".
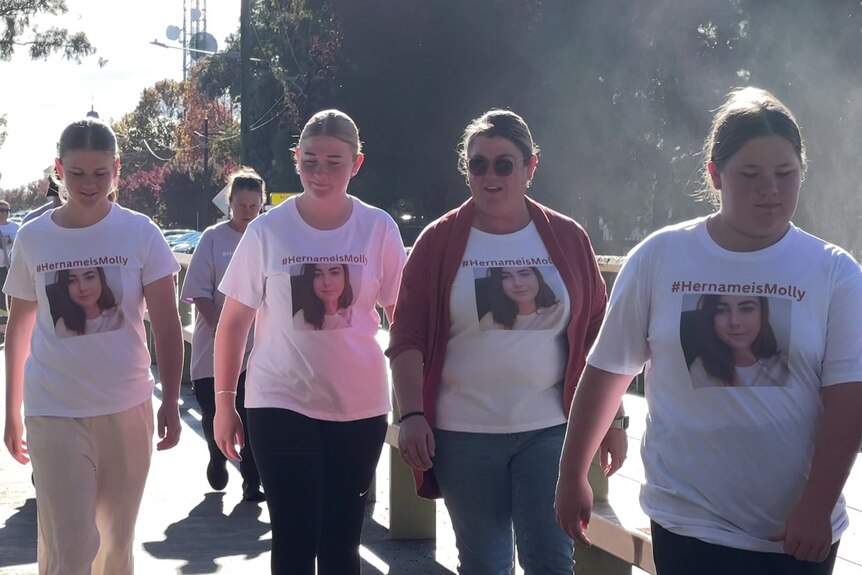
[{"xmin": 801, "ymin": 382, "xmax": 862, "ymax": 512}]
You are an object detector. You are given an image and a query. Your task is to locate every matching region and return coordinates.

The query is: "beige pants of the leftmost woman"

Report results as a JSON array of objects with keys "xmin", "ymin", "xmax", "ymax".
[{"xmin": 25, "ymin": 399, "xmax": 154, "ymax": 575}]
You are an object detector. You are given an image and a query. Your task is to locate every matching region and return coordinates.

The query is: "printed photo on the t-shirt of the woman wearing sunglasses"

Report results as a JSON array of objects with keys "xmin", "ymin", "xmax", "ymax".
[{"xmin": 473, "ymin": 266, "xmax": 564, "ymax": 331}]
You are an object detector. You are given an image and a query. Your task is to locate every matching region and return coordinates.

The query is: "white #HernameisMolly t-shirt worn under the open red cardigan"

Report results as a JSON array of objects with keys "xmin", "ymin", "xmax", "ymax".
[{"xmin": 435, "ymin": 222, "xmax": 570, "ymax": 433}]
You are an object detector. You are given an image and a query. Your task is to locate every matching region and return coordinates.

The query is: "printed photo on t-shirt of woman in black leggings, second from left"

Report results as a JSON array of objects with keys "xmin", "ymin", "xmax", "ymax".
[{"xmin": 290, "ymin": 263, "xmax": 362, "ymax": 331}]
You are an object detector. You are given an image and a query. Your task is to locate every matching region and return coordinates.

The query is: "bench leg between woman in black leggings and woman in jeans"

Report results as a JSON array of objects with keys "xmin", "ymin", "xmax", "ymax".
[{"xmin": 389, "ymin": 447, "xmax": 437, "ymax": 539}]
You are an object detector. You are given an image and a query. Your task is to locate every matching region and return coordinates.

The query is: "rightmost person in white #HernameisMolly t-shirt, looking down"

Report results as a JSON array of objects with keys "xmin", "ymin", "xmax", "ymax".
[{"xmin": 556, "ymin": 88, "xmax": 862, "ymax": 575}]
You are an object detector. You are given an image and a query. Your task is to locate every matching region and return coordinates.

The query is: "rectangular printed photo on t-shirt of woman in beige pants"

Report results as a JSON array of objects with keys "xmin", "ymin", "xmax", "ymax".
[{"xmin": 45, "ymin": 266, "xmax": 125, "ymax": 338}]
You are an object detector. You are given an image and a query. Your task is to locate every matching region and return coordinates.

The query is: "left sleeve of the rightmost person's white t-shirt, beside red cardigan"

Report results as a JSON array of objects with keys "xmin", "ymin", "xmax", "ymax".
[{"xmin": 587, "ymin": 241, "xmax": 652, "ymax": 375}]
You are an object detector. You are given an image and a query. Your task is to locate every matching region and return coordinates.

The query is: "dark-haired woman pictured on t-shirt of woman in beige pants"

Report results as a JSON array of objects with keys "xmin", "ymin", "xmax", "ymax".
[{"xmin": 55, "ymin": 266, "xmax": 123, "ymax": 337}]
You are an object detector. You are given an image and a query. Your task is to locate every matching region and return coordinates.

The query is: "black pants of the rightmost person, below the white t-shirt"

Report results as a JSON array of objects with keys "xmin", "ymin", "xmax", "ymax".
[{"xmin": 651, "ymin": 521, "xmax": 838, "ymax": 575}]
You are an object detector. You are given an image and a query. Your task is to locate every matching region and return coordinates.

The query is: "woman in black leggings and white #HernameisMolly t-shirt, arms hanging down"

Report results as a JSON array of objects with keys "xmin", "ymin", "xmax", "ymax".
[{"xmin": 215, "ymin": 110, "xmax": 405, "ymax": 575}]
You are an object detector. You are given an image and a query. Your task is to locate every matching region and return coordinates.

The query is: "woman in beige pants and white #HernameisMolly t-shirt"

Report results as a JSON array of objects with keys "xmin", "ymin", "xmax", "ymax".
[{"xmin": 4, "ymin": 118, "xmax": 183, "ymax": 575}]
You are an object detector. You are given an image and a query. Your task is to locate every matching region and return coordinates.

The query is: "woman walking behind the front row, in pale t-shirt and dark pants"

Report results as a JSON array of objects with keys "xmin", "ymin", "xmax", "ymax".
[{"xmin": 180, "ymin": 167, "xmax": 266, "ymax": 502}]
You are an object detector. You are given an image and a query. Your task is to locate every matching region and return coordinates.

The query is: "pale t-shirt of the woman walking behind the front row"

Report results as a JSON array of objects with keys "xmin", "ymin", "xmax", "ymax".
[{"xmin": 180, "ymin": 222, "xmax": 254, "ymax": 380}]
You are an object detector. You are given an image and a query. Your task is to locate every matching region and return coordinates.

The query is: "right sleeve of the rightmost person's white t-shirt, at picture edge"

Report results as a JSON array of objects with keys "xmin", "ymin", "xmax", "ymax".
[{"xmin": 820, "ymin": 252, "xmax": 862, "ymax": 387}]
